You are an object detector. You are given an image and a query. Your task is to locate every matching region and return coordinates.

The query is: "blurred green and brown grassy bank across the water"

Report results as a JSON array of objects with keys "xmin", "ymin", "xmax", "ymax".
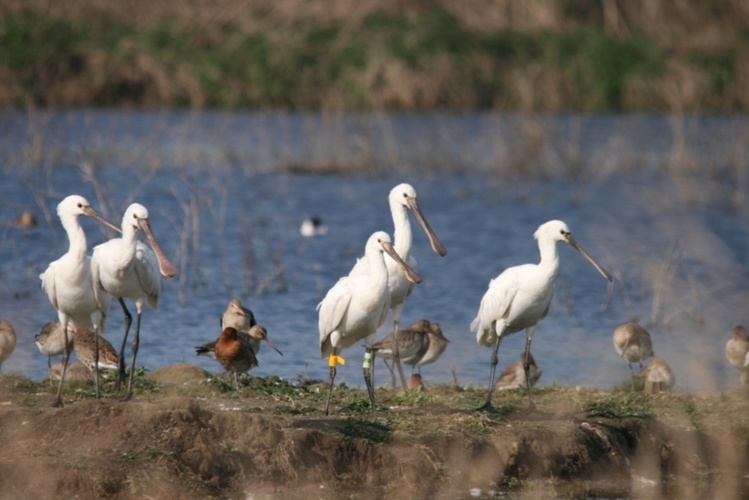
[{"xmin": 0, "ymin": 9, "xmax": 749, "ymax": 111}]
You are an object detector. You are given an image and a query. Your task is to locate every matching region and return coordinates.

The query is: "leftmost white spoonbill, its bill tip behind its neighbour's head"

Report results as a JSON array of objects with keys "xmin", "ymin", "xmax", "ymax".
[{"xmin": 39, "ymin": 195, "xmax": 119, "ymax": 407}]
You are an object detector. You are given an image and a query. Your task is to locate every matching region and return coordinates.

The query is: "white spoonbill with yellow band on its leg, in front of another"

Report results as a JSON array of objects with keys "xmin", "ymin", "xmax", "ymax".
[{"xmin": 317, "ymin": 231, "xmax": 421, "ymax": 415}]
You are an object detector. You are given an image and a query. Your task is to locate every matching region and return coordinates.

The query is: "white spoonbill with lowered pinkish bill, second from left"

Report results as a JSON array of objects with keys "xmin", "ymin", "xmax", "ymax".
[{"xmin": 91, "ymin": 203, "xmax": 177, "ymax": 399}]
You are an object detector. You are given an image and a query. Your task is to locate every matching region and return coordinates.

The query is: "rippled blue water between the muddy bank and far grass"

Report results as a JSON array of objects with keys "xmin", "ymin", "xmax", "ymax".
[{"xmin": 0, "ymin": 111, "xmax": 749, "ymax": 392}]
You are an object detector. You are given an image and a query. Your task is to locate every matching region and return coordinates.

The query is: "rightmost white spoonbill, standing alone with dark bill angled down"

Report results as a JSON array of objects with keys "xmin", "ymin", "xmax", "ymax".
[{"xmin": 471, "ymin": 220, "xmax": 612, "ymax": 409}]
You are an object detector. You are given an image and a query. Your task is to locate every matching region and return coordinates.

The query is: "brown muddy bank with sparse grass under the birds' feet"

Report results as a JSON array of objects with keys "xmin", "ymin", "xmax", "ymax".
[{"xmin": 0, "ymin": 365, "xmax": 749, "ymax": 498}]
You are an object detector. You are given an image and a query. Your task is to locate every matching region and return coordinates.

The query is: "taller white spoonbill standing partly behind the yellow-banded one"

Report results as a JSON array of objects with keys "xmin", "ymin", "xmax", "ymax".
[{"xmin": 350, "ymin": 183, "xmax": 447, "ymax": 388}]
